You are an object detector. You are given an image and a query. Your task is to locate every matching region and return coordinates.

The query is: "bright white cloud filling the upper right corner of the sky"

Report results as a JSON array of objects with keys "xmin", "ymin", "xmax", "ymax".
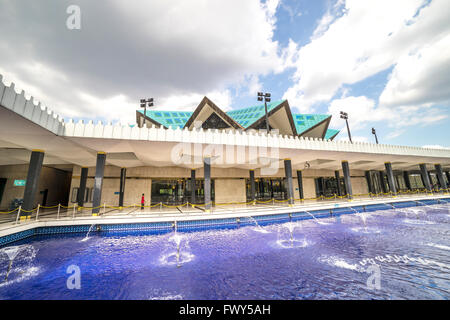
[{"xmin": 284, "ymin": 0, "xmax": 450, "ymax": 112}]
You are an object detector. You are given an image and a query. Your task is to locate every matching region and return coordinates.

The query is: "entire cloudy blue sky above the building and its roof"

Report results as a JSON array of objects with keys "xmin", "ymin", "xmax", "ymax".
[{"xmin": 0, "ymin": 0, "xmax": 450, "ymax": 147}]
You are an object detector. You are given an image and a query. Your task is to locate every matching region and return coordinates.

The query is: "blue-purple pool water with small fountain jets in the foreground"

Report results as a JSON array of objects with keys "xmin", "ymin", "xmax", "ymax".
[{"xmin": 0, "ymin": 204, "xmax": 450, "ymax": 299}]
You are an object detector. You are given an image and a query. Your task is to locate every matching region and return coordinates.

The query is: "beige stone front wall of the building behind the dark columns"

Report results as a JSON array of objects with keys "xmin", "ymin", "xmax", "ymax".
[{"xmin": 67, "ymin": 166, "xmax": 368, "ymax": 206}]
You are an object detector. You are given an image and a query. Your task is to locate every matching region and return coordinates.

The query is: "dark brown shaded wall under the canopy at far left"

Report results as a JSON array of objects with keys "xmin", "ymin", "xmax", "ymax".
[{"xmin": 0, "ymin": 164, "xmax": 72, "ymax": 210}]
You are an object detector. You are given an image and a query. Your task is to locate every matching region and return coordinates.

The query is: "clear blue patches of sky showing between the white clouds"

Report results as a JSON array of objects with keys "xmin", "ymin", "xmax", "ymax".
[{"xmin": 233, "ymin": 0, "xmax": 450, "ymax": 147}]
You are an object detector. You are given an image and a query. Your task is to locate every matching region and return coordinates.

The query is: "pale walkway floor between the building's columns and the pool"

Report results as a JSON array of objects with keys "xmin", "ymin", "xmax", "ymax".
[{"xmin": 0, "ymin": 194, "xmax": 450, "ymax": 236}]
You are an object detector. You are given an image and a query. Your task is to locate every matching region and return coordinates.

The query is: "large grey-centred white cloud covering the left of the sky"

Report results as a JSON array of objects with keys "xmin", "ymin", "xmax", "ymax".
[{"xmin": 0, "ymin": 0, "xmax": 284, "ymax": 121}]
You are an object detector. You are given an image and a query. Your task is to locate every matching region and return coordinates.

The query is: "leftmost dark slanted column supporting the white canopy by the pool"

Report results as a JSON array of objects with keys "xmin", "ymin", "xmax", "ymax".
[{"xmin": 22, "ymin": 150, "xmax": 44, "ymax": 216}]
